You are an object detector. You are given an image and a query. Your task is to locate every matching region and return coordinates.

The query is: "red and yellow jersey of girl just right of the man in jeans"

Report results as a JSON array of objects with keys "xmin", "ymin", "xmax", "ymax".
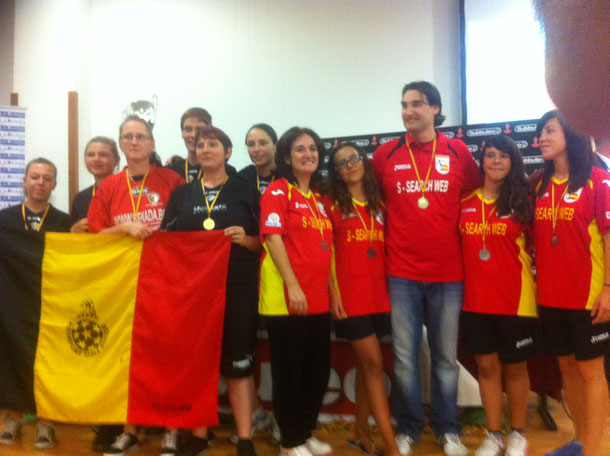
[{"xmin": 459, "ymin": 189, "xmax": 536, "ymax": 317}]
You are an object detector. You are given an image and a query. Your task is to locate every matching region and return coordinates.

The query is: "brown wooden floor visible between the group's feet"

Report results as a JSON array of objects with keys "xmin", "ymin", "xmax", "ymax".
[{"xmin": 0, "ymin": 395, "xmax": 610, "ymax": 456}]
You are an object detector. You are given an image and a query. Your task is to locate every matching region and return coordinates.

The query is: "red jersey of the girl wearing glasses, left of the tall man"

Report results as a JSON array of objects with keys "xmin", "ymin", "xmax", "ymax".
[{"xmin": 330, "ymin": 201, "xmax": 390, "ymax": 317}]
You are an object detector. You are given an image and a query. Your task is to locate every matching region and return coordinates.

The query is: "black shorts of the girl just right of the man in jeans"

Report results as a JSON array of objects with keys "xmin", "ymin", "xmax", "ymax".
[{"xmin": 462, "ymin": 312, "xmax": 539, "ymax": 364}]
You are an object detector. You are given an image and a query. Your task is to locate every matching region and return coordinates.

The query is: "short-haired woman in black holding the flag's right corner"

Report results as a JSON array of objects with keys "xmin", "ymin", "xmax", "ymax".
[{"xmin": 162, "ymin": 126, "xmax": 260, "ymax": 456}]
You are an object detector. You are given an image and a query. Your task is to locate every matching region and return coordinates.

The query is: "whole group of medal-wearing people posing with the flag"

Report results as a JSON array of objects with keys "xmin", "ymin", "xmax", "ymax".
[{"xmin": 0, "ymin": 81, "xmax": 610, "ymax": 456}]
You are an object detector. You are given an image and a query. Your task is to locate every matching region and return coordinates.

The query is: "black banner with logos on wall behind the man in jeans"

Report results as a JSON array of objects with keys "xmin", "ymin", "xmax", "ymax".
[{"xmin": 324, "ymin": 119, "xmax": 543, "ymax": 174}]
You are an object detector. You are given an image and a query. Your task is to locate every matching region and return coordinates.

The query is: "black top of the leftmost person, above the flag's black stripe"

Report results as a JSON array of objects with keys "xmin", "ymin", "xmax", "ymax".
[{"xmin": 0, "ymin": 204, "xmax": 72, "ymax": 233}]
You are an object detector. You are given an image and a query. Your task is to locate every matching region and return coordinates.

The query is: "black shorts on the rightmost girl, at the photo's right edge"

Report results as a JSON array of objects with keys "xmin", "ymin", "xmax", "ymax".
[{"xmin": 538, "ymin": 306, "xmax": 610, "ymax": 361}]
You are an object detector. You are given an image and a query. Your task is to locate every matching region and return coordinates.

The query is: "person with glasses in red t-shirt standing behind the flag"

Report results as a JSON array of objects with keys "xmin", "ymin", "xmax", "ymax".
[{"xmin": 87, "ymin": 116, "xmax": 184, "ymax": 455}]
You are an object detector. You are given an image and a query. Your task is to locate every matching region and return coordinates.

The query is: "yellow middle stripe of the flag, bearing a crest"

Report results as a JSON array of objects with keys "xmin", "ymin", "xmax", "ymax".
[{"xmin": 34, "ymin": 233, "xmax": 142, "ymax": 423}]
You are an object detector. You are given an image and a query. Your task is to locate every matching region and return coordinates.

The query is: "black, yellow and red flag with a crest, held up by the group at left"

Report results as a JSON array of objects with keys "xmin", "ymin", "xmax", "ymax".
[{"xmin": 0, "ymin": 232, "xmax": 230, "ymax": 427}]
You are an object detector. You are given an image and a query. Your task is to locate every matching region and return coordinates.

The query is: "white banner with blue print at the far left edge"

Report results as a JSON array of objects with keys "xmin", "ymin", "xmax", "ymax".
[{"xmin": 0, "ymin": 106, "xmax": 25, "ymax": 209}]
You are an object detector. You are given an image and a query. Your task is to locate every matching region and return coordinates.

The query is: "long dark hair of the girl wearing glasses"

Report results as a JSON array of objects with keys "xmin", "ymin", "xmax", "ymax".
[{"xmin": 328, "ymin": 142, "xmax": 381, "ymax": 215}]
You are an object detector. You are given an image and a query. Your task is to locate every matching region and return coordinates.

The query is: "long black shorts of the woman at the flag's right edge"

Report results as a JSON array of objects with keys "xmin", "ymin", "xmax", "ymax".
[{"xmin": 220, "ymin": 281, "xmax": 258, "ymax": 378}]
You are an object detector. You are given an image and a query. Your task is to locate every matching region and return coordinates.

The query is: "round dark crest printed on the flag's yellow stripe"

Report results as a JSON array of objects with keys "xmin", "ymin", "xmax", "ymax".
[{"xmin": 66, "ymin": 300, "xmax": 108, "ymax": 357}]
